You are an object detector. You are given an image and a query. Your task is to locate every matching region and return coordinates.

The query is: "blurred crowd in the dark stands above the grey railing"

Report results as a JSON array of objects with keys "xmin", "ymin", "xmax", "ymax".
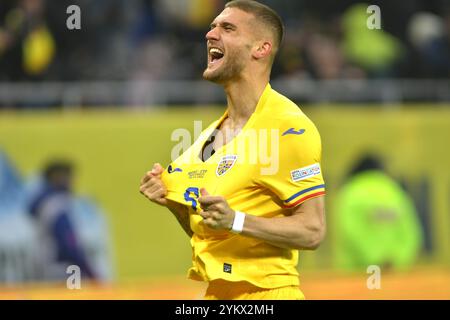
[{"xmin": 0, "ymin": 0, "xmax": 450, "ymax": 81}]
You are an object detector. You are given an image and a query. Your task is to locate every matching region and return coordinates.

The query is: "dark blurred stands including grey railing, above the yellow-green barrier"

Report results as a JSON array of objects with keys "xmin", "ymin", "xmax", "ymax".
[{"xmin": 0, "ymin": 0, "xmax": 450, "ymax": 107}]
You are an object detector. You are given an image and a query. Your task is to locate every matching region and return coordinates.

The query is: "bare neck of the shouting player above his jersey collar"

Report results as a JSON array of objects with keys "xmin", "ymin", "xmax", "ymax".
[{"xmin": 224, "ymin": 75, "xmax": 269, "ymax": 127}]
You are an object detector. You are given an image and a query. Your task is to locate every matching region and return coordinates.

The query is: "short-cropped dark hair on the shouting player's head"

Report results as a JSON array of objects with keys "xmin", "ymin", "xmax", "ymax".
[{"xmin": 225, "ymin": 0, "xmax": 284, "ymax": 48}]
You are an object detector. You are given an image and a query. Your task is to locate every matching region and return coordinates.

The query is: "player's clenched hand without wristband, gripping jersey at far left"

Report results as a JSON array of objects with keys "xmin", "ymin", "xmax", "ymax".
[{"xmin": 139, "ymin": 163, "xmax": 168, "ymax": 206}]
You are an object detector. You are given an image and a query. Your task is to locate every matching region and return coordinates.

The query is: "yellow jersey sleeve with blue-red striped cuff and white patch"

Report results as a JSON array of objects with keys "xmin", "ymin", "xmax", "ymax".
[{"xmin": 258, "ymin": 114, "xmax": 325, "ymax": 208}]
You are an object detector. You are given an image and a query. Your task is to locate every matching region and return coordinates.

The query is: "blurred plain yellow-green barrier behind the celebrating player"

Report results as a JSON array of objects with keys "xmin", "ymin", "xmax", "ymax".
[{"xmin": 0, "ymin": 106, "xmax": 450, "ymax": 279}]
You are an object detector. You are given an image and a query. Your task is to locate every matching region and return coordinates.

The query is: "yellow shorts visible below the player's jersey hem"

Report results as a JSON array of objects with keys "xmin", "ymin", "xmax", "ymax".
[{"xmin": 204, "ymin": 280, "xmax": 305, "ymax": 300}]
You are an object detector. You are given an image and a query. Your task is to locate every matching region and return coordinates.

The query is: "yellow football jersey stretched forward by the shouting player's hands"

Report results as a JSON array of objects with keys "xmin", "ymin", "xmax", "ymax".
[{"xmin": 162, "ymin": 84, "xmax": 325, "ymax": 288}]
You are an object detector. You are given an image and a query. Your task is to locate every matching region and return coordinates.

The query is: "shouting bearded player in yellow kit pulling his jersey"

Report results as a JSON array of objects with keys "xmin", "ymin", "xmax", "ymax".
[{"xmin": 140, "ymin": 0, "xmax": 325, "ymax": 299}]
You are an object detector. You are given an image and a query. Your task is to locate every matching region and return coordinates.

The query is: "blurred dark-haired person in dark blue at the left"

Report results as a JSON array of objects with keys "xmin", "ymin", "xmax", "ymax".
[{"xmin": 29, "ymin": 161, "xmax": 96, "ymax": 280}]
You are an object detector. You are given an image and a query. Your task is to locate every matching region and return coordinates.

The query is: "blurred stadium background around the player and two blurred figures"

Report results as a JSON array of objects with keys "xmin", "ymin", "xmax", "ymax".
[{"xmin": 0, "ymin": 0, "xmax": 450, "ymax": 299}]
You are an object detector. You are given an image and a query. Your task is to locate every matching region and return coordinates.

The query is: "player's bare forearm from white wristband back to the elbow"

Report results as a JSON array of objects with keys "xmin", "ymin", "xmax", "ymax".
[{"xmin": 242, "ymin": 215, "xmax": 325, "ymax": 250}]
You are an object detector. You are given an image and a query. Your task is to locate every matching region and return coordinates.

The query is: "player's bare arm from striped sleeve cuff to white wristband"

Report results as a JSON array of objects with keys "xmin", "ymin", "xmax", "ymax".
[{"xmin": 241, "ymin": 197, "xmax": 326, "ymax": 250}]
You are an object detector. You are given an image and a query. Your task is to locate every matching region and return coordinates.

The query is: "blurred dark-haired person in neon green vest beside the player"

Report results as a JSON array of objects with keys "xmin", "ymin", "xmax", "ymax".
[{"xmin": 335, "ymin": 154, "xmax": 423, "ymax": 271}]
